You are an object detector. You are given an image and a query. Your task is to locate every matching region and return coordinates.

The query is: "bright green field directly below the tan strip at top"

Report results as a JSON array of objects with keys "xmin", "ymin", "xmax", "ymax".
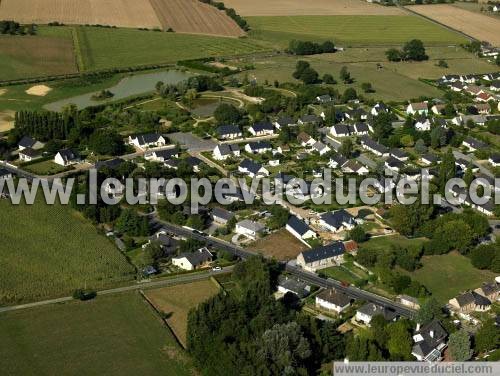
[{"xmin": 247, "ymin": 16, "xmax": 465, "ymax": 48}]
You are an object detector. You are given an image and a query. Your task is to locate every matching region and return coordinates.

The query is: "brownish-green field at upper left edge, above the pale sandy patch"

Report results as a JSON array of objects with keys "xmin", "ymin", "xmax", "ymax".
[{"xmin": 0, "ymin": 26, "xmax": 77, "ymax": 80}]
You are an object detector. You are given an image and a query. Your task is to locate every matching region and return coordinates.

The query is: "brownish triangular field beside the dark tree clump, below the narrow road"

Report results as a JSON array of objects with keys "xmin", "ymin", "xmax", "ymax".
[{"xmin": 144, "ymin": 279, "xmax": 219, "ymax": 347}]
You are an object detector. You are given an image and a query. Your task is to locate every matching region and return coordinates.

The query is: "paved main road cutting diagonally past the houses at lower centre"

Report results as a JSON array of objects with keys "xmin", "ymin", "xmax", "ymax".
[{"xmin": 152, "ymin": 219, "xmax": 416, "ymax": 317}]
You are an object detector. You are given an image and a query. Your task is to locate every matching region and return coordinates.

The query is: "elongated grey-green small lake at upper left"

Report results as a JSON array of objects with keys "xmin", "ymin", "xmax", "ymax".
[{"xmin": 44, "ymin": 70, "xmax": 192, "ymax": 111}]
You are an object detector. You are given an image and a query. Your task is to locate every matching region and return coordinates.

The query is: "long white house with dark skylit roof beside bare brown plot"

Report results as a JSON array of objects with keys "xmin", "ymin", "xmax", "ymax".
[{"xmin": 297, "ymin": 241, "xmax": 345, "ymax": 272}]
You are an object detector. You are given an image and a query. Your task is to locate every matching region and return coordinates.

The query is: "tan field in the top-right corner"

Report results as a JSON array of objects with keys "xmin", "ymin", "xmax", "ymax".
[{"xmin": 408, "ymin": 4, "xmax": 500, "ymax": 46}]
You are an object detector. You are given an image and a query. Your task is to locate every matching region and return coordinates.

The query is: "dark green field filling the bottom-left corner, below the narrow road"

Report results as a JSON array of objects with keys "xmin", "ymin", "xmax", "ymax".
[{"xmin": 0, "ymin": 293, "xmax": 195, "ymax": 376}]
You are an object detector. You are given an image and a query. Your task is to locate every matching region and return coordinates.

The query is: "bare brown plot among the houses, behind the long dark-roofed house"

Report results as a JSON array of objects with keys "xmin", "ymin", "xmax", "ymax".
[{"xmin": 250, "ymin": 229, "xmax": 308, "ymax": 260}]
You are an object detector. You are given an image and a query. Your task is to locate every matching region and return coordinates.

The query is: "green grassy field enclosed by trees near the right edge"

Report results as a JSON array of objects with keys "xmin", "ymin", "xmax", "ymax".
[{"xmin": 409, "ymin": 252, "xmax": 496, "ymax": 304}]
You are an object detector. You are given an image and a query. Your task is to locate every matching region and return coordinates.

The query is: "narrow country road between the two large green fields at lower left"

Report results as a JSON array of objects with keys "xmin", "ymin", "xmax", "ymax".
[{"xmin": 0, "ymin": 266, "xmax": 233, "ymax": 313}]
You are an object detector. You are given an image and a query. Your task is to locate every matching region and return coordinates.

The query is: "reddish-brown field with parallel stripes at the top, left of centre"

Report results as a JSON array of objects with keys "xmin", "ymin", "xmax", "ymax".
[{"xmin": 150, "ymin": 0, "xmax": 245, "ymax": 37}]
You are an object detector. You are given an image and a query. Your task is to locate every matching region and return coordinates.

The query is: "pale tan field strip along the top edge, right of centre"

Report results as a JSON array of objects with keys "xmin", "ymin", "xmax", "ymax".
[{"xmin": 224, "ymin": 0, "xmax": 405, "ymax": 16}]
